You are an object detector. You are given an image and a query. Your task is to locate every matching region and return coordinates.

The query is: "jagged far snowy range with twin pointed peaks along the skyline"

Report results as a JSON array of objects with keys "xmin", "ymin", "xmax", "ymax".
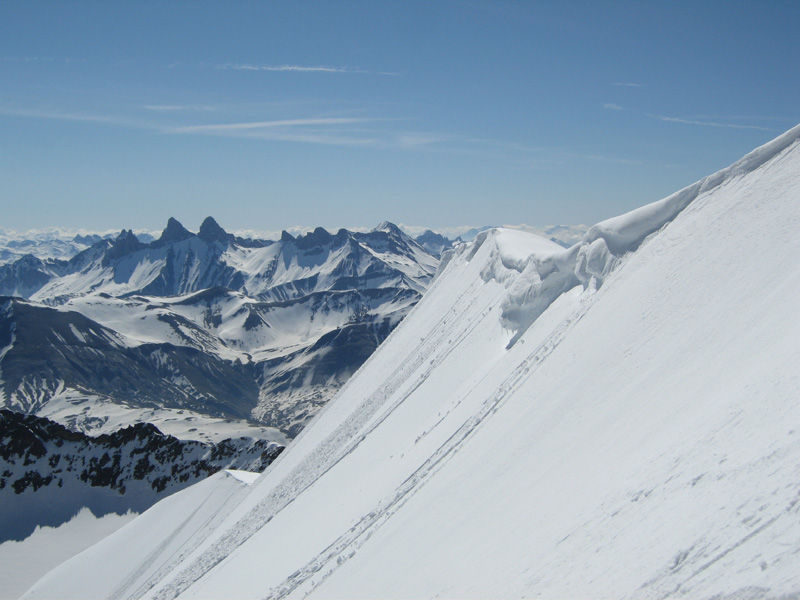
[{"xmin": 0, "ymin": 217, "xmax": 436, "ymax": 303}]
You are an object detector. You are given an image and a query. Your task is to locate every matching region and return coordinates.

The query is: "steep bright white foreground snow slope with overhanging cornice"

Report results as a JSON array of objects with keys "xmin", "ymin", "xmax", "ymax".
[{"xmin": 23, "ymin": 127, "xmax": 800, "ymax": 598}]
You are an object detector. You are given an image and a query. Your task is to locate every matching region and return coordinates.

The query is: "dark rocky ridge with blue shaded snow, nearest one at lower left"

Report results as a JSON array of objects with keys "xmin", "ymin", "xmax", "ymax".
[{"xmin": 0, "ymin": 409, "xmax": 283, "ymax": 542}]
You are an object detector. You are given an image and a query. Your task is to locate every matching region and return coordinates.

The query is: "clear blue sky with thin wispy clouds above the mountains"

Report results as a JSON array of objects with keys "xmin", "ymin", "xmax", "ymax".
[{"xmin": 0, "ymin": 0, "xmax": 800, "ymax": 230}]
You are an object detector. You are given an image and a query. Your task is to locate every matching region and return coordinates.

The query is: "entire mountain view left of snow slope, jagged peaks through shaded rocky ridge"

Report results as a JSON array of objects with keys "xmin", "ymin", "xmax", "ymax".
[{"xmin": 0, "ymin": 217, "xmax": 440, "ymax": 542}]
